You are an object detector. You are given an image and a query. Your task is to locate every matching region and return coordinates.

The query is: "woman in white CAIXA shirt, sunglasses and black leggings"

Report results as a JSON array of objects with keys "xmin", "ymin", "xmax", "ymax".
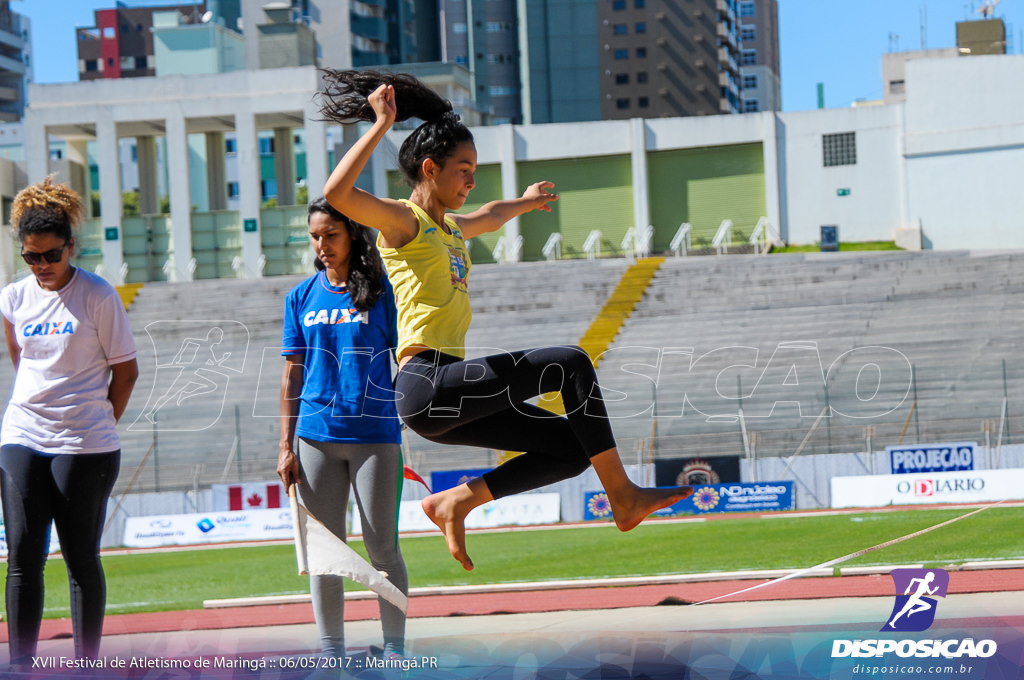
[{"xmin": 0, "ymin": 177, "xmax": 138, "ymax": 668}]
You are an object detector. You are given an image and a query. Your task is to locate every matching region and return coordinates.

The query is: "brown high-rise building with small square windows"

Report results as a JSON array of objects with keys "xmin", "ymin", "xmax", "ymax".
[{"xmin": 597, "ymin": 0, "xmax": 740, "ymax": 120}]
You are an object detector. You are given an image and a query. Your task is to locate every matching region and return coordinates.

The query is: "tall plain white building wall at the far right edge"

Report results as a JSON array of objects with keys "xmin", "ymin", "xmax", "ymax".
[{"xmin": 905, "ymin": 55, "xmax": 1024, "ymax": 249}]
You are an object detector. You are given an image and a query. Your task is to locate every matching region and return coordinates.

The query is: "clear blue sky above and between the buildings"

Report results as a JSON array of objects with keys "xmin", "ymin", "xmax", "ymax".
[{"xmin": 11, "ymin": 0, "xmax": 1024, "ymax": 111}]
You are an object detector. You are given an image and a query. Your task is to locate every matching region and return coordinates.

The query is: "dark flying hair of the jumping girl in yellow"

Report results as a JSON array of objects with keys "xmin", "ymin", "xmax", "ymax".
[{"xmin": 316, "ymin": 69, "xmax": 473, "ymax": 187}]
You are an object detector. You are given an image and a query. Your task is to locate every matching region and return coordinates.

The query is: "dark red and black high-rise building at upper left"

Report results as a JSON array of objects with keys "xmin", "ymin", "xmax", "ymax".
[{"xmin": 77, "ymin": 2, "xmax": 206, "ymax": 81}]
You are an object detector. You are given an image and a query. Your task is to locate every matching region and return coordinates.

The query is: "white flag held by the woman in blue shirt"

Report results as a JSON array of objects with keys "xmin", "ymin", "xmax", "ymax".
[{"xmin": 288, "ymin": 484, "xmax": 409, "ymax": 613}]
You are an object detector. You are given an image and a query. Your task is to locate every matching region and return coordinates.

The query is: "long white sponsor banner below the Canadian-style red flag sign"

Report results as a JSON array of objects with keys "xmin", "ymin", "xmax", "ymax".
[{"xmin": 124, "ymin": 508, "xmax": 295, "ymax": 548}]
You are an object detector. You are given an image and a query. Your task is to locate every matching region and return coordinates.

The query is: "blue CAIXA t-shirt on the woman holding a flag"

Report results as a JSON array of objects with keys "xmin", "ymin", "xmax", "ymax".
[{"xmin": 281, "ymin": 271, "xmax": 401, "ymax": 443}]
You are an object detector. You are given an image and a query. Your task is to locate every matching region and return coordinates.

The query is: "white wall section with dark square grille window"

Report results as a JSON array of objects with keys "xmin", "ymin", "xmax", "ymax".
[{"xmin": 778, "ymin": 105, "xmax": 904, "ymax": 244}]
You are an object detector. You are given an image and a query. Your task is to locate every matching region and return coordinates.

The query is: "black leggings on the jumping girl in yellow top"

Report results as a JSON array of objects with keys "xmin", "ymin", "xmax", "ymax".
[{"xmin": 395, "ymin": 346, "xmax": 615, "ymax": 499}]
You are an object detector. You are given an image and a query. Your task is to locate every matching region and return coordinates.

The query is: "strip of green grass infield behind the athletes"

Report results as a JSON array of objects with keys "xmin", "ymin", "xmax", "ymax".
[{"xmin": 19, "ymin": 508, "xmax": 1024, "ymax": 617}]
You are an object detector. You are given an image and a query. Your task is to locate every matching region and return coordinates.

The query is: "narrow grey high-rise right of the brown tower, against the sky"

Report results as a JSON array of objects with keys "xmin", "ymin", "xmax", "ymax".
[{"xmin": 738, "ymin": 0, "xmax": 782, "ymax": 113}]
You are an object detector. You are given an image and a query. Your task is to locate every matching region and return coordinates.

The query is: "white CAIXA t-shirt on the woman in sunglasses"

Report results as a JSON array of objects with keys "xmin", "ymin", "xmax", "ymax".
[{"xmin": 0, "ymin": 269, "xmax": 135, "ymax": 454}]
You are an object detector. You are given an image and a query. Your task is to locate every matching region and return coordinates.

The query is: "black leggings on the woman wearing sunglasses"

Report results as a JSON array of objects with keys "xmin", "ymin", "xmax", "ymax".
[{"xmin": 0, "ymin": 444, "xmax": 121, "ymax": 664}]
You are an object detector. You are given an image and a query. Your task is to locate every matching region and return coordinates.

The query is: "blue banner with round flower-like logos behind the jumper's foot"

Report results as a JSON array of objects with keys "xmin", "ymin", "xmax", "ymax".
[{"xmin": 583, "ymin": 481, "xmax": 793, "ymax": 519}]
